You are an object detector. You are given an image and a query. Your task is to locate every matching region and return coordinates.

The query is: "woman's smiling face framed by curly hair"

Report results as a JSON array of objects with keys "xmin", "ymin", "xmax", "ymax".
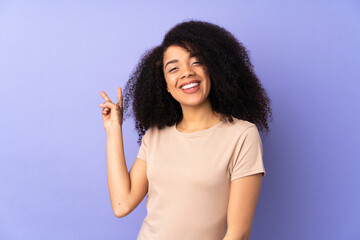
[{"xmin": 163, "ymin": 46, "xmax": 211, "ymax": 106}]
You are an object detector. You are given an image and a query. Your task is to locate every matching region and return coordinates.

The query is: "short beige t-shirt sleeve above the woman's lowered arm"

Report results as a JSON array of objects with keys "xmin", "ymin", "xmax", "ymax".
[{"xmin": 230, "ymin": 125, "xmax": 266, "ymax": 181}]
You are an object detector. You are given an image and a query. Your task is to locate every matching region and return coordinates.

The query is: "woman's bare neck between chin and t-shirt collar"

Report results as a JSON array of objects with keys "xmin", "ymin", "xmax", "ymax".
[{"xmin": 177, "ymin": 99, "xmax": 220, "ymax": 131}]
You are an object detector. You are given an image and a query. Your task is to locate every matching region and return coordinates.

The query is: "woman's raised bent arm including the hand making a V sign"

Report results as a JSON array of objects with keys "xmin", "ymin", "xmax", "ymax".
[{"xmin": 100, "ymin": 87, "xmax": 148, "ymax": 217}]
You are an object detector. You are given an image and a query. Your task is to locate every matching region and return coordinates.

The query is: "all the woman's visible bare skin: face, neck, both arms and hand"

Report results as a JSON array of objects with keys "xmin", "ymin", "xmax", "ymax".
[{"xmin": 99, "ymin": 46, "xmax": 262, "ymax": 240}]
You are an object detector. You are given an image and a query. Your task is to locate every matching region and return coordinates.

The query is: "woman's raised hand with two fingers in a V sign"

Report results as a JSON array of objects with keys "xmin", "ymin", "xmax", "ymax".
[{"xmin": 99, "ymin": 87, "xmax": 124, "ymax": 131}]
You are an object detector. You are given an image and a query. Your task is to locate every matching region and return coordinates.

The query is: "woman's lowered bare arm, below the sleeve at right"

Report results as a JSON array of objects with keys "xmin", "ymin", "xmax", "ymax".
[{"xmin": 223, "ymin": 173, "xmax": 262, "ymax": 240}]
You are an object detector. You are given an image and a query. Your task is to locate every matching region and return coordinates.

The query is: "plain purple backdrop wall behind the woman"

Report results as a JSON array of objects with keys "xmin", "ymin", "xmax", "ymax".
[{"xmin": 0, "ymin": 0, "xmax": 360, "ymax": 240}]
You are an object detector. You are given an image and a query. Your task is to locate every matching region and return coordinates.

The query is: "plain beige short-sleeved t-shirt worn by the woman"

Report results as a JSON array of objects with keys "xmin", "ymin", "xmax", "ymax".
[{"xmin": 137, "ymin": 118, "xmax": 266, "ymax": 240}]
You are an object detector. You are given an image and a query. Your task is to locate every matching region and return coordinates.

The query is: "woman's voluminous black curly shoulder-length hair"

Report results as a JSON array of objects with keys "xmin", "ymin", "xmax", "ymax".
[{"xmin": 123, "ymin": 20, "xmax": 272, "ymax": 144}]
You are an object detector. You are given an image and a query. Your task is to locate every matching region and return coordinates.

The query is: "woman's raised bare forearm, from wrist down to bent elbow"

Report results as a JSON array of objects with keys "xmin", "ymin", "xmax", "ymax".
[{"xmin": 106, "ymin": 126, "xmax": 130, "ymax": 217}]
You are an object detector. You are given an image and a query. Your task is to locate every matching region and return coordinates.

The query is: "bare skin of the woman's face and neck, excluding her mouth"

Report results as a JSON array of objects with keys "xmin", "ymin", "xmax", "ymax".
[{"xmin": 163, "ymin": 46, "xmax": 220, "ymax": 132}]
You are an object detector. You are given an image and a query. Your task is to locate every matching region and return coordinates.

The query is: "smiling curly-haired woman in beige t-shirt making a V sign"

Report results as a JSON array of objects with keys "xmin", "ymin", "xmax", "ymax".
[{"xmin": 100, "ymin": 21, "xmax": 271, "ymax": 240}]
